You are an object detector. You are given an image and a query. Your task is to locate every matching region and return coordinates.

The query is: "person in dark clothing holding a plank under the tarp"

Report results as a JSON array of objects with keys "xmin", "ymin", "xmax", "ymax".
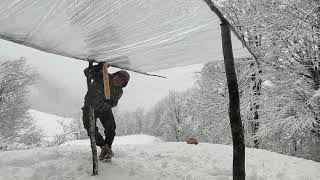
[{"xmin": 82, "ymin": 63, "xmax": 130, "ymax": 160}]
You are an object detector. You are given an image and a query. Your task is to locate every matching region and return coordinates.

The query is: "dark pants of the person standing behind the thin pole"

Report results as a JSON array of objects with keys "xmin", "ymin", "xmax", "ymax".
[{"xmin": 82, "ymin": 105, "xmax": 116, "ymax": 147}]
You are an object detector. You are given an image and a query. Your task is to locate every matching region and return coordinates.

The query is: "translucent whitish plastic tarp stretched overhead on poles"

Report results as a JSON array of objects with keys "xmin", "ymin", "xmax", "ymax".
[{"xmin": 0, "ymin": 0, "xmax": 249, "ymax": 71}]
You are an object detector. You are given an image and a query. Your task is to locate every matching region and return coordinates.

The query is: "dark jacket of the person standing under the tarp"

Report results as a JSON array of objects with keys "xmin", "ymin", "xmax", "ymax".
[{"xmin": 84, "ymin": 64, "xmax": 129, "ymax": 112}]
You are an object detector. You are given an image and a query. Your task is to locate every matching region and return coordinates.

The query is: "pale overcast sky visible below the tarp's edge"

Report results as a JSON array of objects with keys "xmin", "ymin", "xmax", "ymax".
[{"xmin": 0, "ymin": 40, "xmax": 203, "ymax": 110}]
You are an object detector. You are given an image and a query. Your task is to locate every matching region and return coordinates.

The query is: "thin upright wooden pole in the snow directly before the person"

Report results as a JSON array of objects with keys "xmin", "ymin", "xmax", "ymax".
[{"xmin": 87, "ymin": 62, "xmax": 98, "ymax": 176}]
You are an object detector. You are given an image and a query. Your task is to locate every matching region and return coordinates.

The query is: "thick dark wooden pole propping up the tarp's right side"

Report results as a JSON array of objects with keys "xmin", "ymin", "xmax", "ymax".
[{"xmin": 204, "ymin": 0, "xmax": 246, "ymax": 180}]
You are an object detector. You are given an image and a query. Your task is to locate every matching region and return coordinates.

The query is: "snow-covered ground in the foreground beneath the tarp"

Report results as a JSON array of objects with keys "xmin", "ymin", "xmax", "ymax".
[{"xmin": 0, "ymin": 135, "xmax": 320, "ymax": 180}]
